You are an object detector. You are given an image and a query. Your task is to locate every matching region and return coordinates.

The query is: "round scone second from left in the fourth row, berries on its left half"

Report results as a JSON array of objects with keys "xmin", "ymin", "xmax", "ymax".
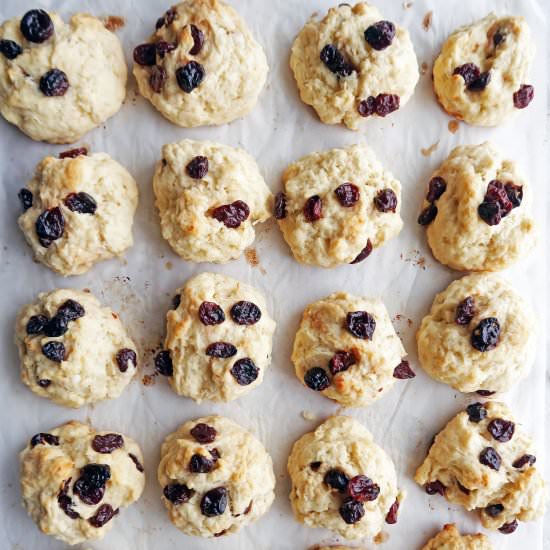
[{"xmin": 158, "ymin": 416, "xmax": 275, "ymax": 538}]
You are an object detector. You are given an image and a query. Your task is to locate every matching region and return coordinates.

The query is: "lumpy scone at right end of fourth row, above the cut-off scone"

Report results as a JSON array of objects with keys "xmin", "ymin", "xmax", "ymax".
[{"xmin": 414, "ymin": 401, "xmax": 547, "ymax": 534}]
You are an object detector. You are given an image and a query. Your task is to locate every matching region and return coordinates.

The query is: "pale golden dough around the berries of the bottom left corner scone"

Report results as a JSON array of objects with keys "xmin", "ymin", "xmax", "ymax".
[{"xmin": 19, "ymin": 420, "xmax": 145, "ymax": 545}]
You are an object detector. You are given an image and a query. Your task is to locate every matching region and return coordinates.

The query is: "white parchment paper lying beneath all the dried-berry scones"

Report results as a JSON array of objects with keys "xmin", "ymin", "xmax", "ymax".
[{"xmin": 0, "ymin": 0, "xmax": 548, "ymax": 550}]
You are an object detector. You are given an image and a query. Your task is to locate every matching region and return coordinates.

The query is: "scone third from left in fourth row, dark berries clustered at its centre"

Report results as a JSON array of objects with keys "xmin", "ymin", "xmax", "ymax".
[{"xmin": 288, "ymin": 416, "xmax": 399, "ymax": 539}]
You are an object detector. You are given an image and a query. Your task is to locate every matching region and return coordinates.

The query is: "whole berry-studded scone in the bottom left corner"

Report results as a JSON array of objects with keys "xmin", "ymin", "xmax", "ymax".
[{"xmin": 19, "ymin": 420, "xmax": 145, "ymax": 545}]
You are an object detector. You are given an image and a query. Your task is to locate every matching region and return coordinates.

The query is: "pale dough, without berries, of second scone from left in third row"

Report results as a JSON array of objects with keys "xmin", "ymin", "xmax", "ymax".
[{"xmin": 165, "ymin": 273, "xmax": 275, "ymax": 403}]
